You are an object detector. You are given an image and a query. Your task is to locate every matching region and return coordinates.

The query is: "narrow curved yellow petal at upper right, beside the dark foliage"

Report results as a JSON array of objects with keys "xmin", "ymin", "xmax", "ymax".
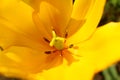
[{"xmin": 68, "ymin": 0, "xmax": 105, "ymax": 43}]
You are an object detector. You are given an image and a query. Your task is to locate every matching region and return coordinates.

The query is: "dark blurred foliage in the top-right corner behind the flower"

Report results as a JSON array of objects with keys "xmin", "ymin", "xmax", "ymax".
[{"xmin": 99, "ymin": 0, "xmax": 120, "ymax": 25}]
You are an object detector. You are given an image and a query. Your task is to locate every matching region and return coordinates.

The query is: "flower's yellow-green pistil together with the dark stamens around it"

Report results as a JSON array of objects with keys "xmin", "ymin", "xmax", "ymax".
[{"xmin": 43, "ymin": 30, "xmax": 78, "ymax": 56}]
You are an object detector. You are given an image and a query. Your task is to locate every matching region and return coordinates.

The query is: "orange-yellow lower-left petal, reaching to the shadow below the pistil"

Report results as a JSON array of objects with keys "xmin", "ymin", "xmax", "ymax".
[{"xmin": 0, "ymin": 46, "xmax": 63, "ymax": 80}]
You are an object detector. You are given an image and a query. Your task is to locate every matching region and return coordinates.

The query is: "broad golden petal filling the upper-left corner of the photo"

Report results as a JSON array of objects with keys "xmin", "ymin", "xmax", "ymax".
[{"xmin": 0, "ymin": 0, "xmax": 49, "ymax": 39}]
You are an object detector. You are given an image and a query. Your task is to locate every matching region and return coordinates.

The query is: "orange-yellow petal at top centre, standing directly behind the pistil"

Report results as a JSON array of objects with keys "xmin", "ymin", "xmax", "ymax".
[{"xmin": 31, "ymin": 0, "xmax": 72, "ymax": 35}]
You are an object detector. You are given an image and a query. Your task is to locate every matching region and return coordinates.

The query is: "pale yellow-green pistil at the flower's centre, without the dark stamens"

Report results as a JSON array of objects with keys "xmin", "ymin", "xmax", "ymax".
[{"xmin": 49, "ymin": 31, "xmax": 65, "ymax": 50}]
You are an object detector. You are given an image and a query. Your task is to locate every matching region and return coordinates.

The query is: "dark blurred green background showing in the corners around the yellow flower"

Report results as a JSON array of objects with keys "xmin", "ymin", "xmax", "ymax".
[{"xmin": 0, "ymin": 0, "xmax": 120, "ymax": 80}]
